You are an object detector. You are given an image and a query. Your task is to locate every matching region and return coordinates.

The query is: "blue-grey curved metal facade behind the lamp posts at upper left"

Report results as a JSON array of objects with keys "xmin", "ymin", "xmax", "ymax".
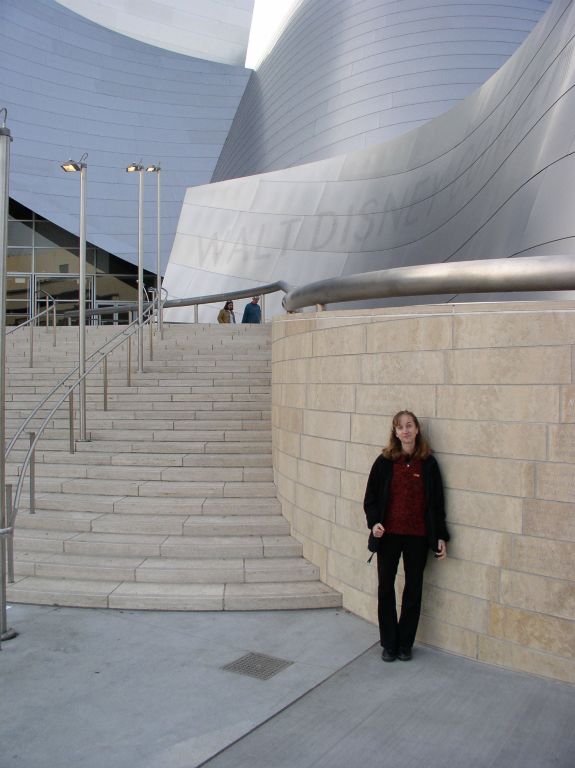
[{"xmin": 0, "ymin": 0, "xmax": 249, "ymax": 272}]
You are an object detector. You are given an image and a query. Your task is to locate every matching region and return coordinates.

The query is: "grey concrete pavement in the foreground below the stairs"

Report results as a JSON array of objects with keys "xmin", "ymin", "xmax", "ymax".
[{"xmin": 0, "ymin": 605, "xmax": 575, "ymax": 768}]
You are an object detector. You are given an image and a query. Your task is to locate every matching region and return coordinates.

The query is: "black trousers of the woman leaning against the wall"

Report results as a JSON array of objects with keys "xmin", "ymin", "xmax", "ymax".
[{"xmin": 377, "ymin": 533, "xmax": 429, "ymax": 654}]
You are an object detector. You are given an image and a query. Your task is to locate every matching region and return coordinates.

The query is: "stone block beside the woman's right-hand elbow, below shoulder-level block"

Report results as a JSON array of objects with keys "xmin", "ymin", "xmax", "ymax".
[{"xmin": 447, "ymin": 489, "xmax": 524, "ymax": 533}]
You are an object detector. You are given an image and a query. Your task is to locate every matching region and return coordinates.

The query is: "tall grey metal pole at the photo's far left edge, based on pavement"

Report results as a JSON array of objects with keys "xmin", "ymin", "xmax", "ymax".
[{"xmin": 0, "ymin": 108, "xmax": 15, "ymax": 641}]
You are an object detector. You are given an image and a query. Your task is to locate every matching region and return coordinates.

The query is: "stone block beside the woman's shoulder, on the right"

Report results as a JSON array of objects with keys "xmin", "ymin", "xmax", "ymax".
[{"xmin": 446, "ymin": 454, "xmax": 534, "ymax": 498}]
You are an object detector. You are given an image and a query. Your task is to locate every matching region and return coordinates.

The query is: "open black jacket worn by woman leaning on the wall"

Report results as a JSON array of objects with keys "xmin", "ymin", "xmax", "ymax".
[{"xmin": 363, "ymin": 454, "xmax": 449, "ymax": 552}]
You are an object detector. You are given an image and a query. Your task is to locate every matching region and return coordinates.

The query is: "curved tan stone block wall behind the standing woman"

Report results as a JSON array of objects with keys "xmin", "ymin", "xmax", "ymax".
[{"xmin": 273, "ymin": 302, "xmax": 575, "ymax": 683}]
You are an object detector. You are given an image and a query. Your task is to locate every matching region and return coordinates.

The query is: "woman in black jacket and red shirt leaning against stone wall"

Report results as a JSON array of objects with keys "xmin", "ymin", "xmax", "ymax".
[{"xmin": 363, "ymin": 411, "xmax": 449, "ymax": 661}]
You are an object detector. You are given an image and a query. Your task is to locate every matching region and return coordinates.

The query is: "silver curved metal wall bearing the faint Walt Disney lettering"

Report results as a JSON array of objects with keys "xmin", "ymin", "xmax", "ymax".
[{"xmin": 162, "ymin": 0, "xmax": 575, "ymax": 316}]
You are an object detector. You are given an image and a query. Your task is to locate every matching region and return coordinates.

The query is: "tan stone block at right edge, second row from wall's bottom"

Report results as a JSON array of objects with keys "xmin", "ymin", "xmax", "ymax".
[{"xmin": 487, "ymin": 605, "xmax": 575, "ymax": 658}]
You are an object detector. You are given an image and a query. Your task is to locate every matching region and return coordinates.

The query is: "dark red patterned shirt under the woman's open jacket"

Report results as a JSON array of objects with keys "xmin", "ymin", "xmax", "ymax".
[{"xmin": 384, "ymin": 456, "xmax": 427, "ymax": 536}]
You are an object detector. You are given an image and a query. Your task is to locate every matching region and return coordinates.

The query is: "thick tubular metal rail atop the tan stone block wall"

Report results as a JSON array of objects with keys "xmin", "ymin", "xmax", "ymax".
[{"xmin": 282, "ymin": 256, "xmax": 575, "ymax": 312}]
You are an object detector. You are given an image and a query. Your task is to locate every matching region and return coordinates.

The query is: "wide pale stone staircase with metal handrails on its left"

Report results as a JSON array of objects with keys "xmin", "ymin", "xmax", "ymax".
[{"xmin": 7, "ymin": 325, "xmax": 341, "ymax": 610}]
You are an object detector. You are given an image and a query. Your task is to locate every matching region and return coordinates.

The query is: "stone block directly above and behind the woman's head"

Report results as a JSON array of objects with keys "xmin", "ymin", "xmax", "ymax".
[{"xmin": 355, "ymin": 384, "xmax": 437, "ymax": 424}]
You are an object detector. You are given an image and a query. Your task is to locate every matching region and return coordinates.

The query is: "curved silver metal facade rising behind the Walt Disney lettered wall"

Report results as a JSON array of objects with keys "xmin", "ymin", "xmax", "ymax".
[{"xmin": 212, "ymin": 0, "xmax": 550, "ymax": 181}]
